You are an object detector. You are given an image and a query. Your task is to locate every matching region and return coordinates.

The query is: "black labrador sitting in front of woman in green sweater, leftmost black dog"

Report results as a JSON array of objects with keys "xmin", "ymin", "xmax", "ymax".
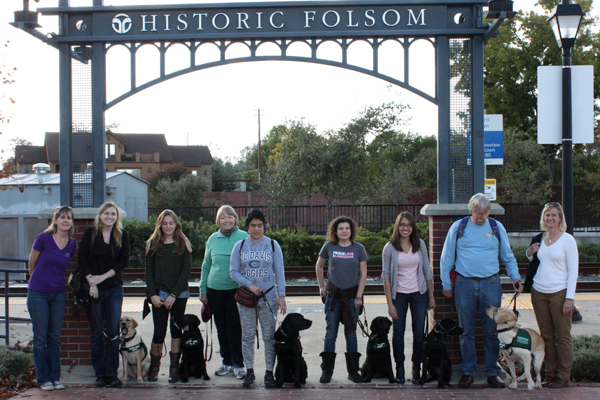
[{"xmin": 179, "ymin": 314, "xmax": 210, "ymax": 382}]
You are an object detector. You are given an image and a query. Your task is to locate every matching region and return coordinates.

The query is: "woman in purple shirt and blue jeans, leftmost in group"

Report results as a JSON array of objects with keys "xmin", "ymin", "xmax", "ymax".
[{"xmin": 27, "ymin": 206, "xmax": 77, "ymax": 390}]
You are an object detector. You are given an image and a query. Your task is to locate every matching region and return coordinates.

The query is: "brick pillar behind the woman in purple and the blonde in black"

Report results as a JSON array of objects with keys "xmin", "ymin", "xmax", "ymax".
[{"xmin": 40, "ymin": 208, "xmax": 98, "ymax": 365}]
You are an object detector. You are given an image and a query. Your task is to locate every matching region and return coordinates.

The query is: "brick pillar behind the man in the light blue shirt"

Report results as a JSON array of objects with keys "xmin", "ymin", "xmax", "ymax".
[{"xmin": 421, "ymin": 203, "xmax": 504, "ymax": 365}]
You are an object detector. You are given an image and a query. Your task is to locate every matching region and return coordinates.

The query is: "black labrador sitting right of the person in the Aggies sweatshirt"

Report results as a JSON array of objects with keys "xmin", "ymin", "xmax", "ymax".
[{"xmin": 274, "ymin": 313, "xmax": 312, "ymax": 388}]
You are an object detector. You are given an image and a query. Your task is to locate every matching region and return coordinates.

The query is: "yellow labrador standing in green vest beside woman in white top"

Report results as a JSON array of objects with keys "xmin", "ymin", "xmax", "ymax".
[{"xmin": 486, "ymin": 306, "xmax": 546, "ymax": 390}]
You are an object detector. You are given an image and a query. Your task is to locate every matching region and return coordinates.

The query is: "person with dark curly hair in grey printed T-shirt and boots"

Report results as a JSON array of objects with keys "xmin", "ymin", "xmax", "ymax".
[{"xmin": 316, "ymin": 217, "xmax": 368, "ymax": 383}]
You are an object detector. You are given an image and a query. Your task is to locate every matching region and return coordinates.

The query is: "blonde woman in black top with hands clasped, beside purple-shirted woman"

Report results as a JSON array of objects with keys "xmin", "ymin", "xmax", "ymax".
[{"xmin": 79, "ymin": 202, "xmax": 129, "ymax": 387}]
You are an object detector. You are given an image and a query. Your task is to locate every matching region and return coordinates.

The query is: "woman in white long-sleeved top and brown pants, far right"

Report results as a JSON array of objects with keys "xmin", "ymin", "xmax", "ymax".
[{"xmin": 527, "ymin": 203, "xmax": 579, "ymax": 388}]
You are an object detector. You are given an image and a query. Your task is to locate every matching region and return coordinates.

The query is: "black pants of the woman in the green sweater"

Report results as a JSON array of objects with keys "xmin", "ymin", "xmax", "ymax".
[{"xmin": 206, "ymin": 288, "xmax": 244, "ymax": 367}]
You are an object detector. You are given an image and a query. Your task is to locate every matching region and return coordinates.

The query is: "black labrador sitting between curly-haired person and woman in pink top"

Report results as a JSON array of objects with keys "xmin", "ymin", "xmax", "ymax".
[{"xmin": 360, "ymin": 317, "xmax": 396, "ymax": 383}]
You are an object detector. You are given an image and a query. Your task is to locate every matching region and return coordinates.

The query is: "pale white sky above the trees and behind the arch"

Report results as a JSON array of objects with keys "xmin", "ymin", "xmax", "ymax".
[{"xmin": 0, "ymin": 0, "xmax": 584, "ymax": 160}]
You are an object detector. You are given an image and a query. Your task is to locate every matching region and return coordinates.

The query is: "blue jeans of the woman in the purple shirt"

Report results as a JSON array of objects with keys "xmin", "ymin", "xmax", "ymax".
[{"xmin": 27, "ymin": 290, "xmax": 65, "ymax": 385}]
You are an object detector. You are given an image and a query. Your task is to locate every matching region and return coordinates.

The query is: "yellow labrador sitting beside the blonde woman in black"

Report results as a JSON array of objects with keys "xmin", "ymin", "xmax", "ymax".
[{"xmin": 119, "ymin": 317, "xmax": 150, "ymax": 383}]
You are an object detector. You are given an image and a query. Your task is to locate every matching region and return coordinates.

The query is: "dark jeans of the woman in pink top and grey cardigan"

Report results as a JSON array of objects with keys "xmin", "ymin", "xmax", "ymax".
[{"xmin": 392, "ymin": 292, "xmax": 429, "ymax": 368}]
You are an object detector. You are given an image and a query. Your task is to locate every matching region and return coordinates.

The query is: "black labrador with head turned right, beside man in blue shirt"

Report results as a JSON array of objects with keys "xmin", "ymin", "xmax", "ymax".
[{"xmin": 419, "ymin": 319, "xmax": 463, "ymax": 388}]
